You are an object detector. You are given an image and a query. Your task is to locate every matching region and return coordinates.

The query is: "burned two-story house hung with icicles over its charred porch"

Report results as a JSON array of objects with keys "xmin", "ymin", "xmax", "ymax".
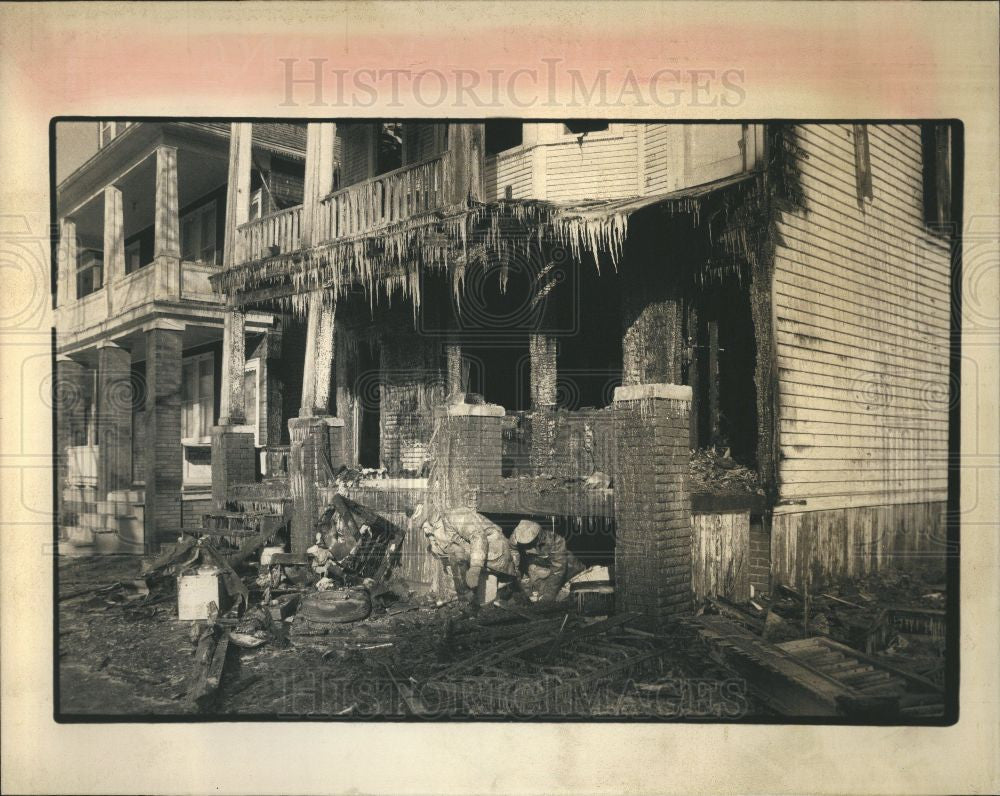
[{"xmin": 201, "ymin": 120, "xmax": 952, "ymax": 611}]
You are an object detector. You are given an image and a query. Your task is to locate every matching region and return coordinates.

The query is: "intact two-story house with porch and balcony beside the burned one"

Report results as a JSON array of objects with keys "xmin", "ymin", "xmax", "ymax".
[{"xmin": 55, "ymin": 121, "xmax": 304, "ymax": 552}]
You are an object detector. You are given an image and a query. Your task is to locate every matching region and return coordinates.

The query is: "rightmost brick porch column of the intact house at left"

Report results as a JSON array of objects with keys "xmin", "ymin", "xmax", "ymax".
[{"xmin": 145, "ymin": 327, "xmax": 184, "ymax": 551}]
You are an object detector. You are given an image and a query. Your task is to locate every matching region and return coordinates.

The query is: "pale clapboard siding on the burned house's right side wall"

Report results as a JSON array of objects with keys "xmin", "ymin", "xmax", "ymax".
[{"xmin": 774, "ymin": 125, "xmax": 951, "ymax": 511}]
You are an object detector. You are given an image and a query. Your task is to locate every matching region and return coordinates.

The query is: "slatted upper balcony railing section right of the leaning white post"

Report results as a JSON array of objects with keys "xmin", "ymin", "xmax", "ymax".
[{"xmin": 316, "ymin": 153, "xmax": 447, "ymax": 241}]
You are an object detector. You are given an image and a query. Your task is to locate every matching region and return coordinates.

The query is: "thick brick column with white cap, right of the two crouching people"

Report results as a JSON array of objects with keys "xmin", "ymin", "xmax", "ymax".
[{"xmin": 614, "ymin": 384, "xmax": 693, "ymax": 627}]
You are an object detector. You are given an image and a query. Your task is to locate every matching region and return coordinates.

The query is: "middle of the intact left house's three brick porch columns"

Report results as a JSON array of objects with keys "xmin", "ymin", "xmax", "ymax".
[{"xmin": 97, "ymin": 342, "xmax": 132, "ymax": 500}]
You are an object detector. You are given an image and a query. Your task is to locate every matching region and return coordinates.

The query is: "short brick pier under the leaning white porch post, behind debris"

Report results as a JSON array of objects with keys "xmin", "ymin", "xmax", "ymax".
[{"xmin": 288, "ymin": 417, "xmax": 345, "ymax": 553}]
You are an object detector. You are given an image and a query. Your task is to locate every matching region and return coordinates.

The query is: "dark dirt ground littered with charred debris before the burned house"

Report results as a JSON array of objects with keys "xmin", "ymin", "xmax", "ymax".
[{"xmin": 57, "ymin": 556, "xmax": 943, "ymax": 721}]
